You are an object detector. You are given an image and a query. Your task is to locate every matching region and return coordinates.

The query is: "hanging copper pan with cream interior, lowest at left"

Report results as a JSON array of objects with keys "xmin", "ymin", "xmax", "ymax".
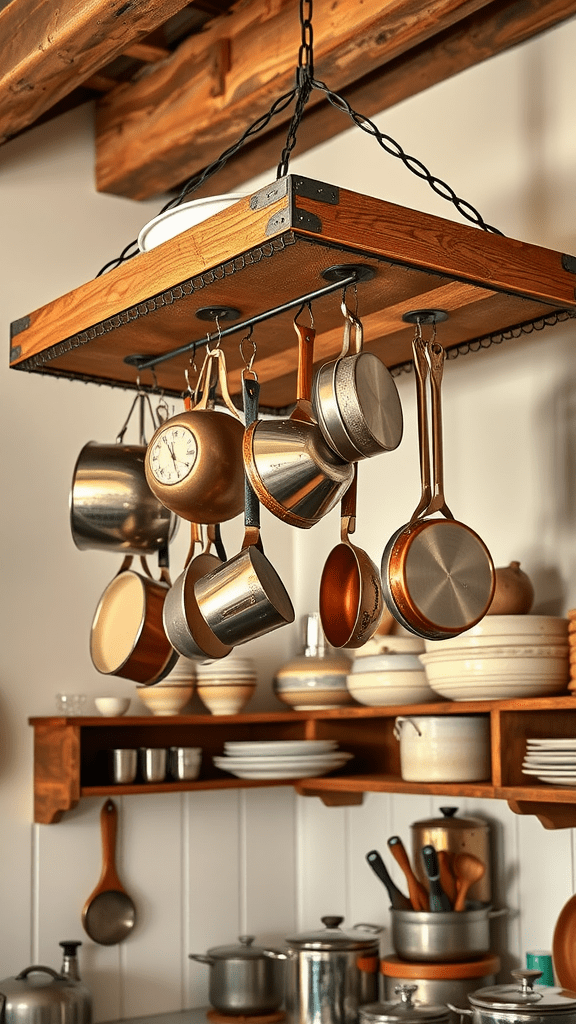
[{"xmin": 90, "ymin": 549, "xmax": 178, "ymax": 686}]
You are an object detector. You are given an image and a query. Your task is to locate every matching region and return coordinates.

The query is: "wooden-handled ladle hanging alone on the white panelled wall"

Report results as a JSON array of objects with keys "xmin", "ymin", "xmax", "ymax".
[{"xmin": 82, "ymin": 800, "xmax": 136, "ymax": 946}]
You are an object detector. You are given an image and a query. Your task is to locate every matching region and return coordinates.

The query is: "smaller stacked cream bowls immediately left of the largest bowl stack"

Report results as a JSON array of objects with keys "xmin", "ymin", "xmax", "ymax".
[{"xmin": 346, "ymin": 637, "xmax": 436, "ymax": 708}]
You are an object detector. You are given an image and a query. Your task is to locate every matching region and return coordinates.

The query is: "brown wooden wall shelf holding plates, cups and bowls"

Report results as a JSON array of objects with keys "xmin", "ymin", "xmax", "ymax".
[{"xmin": 30, "ymin": 695, "xmax": 576, "ymax": 828}]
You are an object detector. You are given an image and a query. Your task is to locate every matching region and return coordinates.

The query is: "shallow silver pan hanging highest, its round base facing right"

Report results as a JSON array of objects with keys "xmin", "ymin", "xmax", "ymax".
[{"xmin": 312, "ymin": 300, "xmax": 404, "ymax": 462}]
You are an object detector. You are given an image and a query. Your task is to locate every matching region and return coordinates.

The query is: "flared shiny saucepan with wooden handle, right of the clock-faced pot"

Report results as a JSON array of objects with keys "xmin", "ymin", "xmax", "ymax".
[{"xmin": 243, "ymin": 322, "xmax": 353, "ymax": 529}]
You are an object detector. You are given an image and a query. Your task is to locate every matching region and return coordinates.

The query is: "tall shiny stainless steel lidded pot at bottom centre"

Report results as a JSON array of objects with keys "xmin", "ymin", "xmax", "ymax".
[{"xmin": 264, "ymin": 918, "xmax": 382, "ymax": 1024}]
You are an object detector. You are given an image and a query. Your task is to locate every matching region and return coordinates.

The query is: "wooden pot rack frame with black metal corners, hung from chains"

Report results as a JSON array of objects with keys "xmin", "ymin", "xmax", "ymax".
[{"xmin": 10, "ymin": 175, "xmax": 576, "ymax": 411}]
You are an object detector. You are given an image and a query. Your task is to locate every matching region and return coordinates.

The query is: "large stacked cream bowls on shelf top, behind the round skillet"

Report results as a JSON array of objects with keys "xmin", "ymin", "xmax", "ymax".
[{"xmin": 421, "ymin": 614, "xmax": 569, "ymax": 700}]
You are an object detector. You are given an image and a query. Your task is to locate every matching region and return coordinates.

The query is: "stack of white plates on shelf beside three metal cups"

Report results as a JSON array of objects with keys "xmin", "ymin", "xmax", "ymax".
[{"xmin": 213, "ymin": 739, "xmax": 354, "ymax": 779}]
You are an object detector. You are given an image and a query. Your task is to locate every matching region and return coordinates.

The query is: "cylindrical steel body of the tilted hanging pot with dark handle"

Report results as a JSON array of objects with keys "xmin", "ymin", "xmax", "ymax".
[{"xmin": 194, "ymin": 544, "xmax": 294, "ymax": 646}]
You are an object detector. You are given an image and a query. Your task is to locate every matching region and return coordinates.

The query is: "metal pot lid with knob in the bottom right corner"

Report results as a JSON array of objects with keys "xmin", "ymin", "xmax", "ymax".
[{"xmin": 468, "ymin": 968, "xmax": 576, "ymax": 1017}]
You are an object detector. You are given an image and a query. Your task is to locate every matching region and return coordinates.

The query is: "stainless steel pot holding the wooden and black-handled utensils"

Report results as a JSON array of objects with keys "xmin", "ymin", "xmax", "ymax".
[{"xmin": 390, "ymin": 906, "xmax": 507, "ymax": 964}]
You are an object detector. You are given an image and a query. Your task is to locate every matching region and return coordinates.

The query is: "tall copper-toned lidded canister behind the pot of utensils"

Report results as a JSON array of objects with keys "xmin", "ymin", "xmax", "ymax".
[{"xmin": 410, "ymin": 807, "xmax": 492, "ymax": 903}]
